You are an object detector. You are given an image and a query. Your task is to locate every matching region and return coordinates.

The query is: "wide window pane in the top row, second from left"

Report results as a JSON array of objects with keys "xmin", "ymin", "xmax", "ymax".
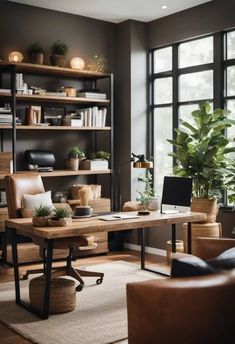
[{"xmin": 179, "ymin": 37, "xmax": 213, "ymax": 68}]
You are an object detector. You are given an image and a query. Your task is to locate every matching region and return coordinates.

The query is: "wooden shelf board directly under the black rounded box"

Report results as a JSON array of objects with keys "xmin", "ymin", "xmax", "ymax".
[{"xmin": 0, "ymin": 169, "xmax": 111, "ymax": 179}]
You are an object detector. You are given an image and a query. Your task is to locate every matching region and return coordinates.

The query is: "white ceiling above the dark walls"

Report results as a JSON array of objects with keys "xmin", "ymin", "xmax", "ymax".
[{"xmin": 8, "ymin": 0, "xmax": 211, "ymax": 23}]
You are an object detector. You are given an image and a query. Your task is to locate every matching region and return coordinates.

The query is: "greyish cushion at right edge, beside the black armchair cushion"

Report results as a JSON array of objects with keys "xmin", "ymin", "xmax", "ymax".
[{"xmin": 207, "ymin": 247, "xmax": 235, "ymax": 270}]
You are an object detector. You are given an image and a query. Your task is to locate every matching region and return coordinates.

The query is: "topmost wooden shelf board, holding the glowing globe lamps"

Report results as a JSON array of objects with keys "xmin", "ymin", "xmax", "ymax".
[{"xmin": 0, "ymin": 62, "xmax": 110, "ymax": 79}]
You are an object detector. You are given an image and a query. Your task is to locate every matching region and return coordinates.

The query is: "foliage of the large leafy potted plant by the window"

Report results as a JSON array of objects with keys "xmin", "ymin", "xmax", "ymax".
[{"xmin": 167, "ymin": 102, "xmax": 235, "ymax": 198}]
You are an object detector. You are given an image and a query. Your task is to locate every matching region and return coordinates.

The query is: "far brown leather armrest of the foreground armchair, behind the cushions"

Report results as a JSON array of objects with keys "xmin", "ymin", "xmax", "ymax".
[{"xmin": 195, "ymin": 238, "xmax": 235, "ymax": 259}]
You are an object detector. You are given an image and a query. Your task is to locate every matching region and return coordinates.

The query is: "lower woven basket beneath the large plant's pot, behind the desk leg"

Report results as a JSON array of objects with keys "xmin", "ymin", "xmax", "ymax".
[{"xmin": 182, "ymin": 222, "xmax": 222, "ymax": 255}]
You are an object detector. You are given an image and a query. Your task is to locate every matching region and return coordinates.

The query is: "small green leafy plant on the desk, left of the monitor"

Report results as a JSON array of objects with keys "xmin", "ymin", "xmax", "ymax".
[{"xmin": 136, "ymin": 171, "xmax": 155, "ymax": 209}]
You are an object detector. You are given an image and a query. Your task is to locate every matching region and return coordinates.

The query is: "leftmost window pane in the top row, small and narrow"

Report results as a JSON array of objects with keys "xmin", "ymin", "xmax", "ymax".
[{"xmin": 153, "ymin": 47, "xmax": 172, "ymax": 73}]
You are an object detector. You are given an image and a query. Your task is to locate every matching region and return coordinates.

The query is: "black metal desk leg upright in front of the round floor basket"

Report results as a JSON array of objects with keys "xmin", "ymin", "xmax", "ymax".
[{"xmin": 42, "ymin": 240, "xmax": 54, "ymax": 319}]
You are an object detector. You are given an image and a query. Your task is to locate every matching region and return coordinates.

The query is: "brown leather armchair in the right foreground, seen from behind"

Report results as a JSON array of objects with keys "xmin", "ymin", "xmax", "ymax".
[{"xmin": 127, "ymin": 238, "xmax": 235, "ymax": 344}]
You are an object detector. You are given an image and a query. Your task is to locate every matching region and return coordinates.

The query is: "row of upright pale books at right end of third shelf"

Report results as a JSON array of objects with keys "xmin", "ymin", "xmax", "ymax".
[{"xmin": 64, "ymin": 106, "xmax": 107, "ymax": 128}]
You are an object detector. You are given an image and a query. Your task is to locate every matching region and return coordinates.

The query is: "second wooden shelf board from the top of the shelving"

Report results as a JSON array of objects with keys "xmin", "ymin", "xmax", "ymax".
[{"xmin": 0, "ymin": 92, "xmax": 110, "ymax": 105}]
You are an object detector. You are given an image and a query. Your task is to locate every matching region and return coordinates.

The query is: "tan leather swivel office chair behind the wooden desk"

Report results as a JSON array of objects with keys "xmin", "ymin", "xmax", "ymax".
[{"xmin": 5, "ymin": 174, "xmax": 104, "ymax": 291}]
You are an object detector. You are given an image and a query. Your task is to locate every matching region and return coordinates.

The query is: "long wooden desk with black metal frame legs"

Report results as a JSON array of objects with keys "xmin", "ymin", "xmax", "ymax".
[{"xmin": 6, "ymin": 212, "xmax": 206, "ymax": 319}]
